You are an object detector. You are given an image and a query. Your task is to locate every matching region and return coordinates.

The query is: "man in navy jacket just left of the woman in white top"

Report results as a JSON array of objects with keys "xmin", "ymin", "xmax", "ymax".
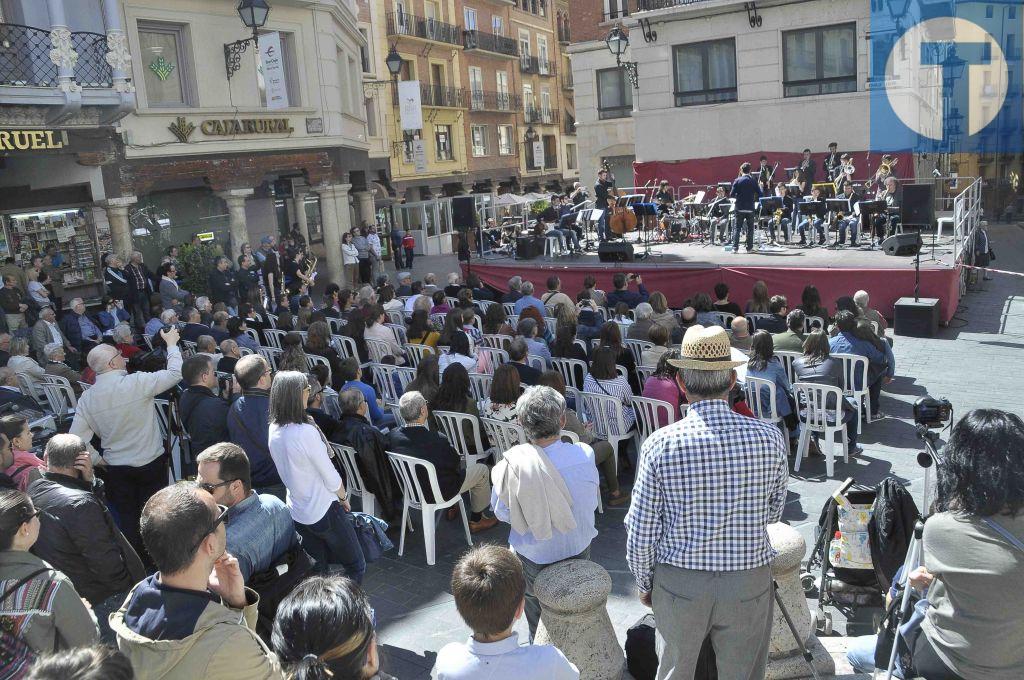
[{"xmin": 227, "ymin": 354, "xmax": 285, "ymax": 500}]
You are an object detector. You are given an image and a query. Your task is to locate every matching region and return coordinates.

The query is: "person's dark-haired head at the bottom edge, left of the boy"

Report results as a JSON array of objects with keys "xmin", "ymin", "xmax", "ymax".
[{"xmin": 270, "ymin": 577, "xmax": 393, "ymax": 680}]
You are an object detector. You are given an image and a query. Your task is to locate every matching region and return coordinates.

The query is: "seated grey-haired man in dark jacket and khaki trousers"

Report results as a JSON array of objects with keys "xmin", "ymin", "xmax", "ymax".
[{"xmin": 387, "ymin": 391, "xmax": 498, "ymax": 533}]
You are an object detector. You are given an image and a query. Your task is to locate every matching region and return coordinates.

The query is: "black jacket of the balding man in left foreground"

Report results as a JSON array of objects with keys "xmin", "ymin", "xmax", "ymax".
[{"xmin": 28, "ymin": 472, "xmax": 145, "ymax": 606}]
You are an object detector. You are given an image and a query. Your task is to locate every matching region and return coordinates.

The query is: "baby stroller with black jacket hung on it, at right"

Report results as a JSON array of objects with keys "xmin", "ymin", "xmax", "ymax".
[{"xmin": 801, "ymin": 477, "xmax": 888, "ymax": 635}]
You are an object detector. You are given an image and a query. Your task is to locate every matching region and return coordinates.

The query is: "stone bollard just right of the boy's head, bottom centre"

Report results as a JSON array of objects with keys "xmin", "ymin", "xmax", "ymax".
[{"xmin": 534, "ymin": 559, "xmax": 626, "ymax": 680}]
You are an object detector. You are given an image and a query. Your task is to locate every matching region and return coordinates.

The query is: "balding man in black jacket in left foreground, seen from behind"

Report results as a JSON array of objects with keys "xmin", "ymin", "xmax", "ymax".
[{"xmin": 28, "ymin": 434, "xmax": 145, "ymax": 640}]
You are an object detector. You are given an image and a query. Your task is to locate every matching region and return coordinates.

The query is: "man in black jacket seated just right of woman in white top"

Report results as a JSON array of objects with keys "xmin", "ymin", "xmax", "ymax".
[{"xmin": 332, "ymin": 387, "xmax": 401, "ymax": 521}]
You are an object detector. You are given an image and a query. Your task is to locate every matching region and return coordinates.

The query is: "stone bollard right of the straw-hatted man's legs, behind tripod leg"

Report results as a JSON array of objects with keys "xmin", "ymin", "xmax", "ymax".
[{"xmin": 765, "ymin": 523, "xmax": 836, "ymax": 680}]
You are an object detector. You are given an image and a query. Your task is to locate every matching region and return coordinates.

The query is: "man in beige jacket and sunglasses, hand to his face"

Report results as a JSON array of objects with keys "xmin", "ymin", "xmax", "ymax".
[{"xmin": 110, "ymin": 484, "xmax": 283, "ymax": 680}]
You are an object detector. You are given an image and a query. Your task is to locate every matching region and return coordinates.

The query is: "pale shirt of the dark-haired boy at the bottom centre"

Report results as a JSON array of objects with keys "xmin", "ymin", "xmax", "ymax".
[{"xmin": 434, "ymin": 633, "xmax": 580, "ymax": 680}]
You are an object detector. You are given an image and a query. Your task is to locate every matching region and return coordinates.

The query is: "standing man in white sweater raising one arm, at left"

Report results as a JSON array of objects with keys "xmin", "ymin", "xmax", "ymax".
[{"xmin": 70, "ymin": 327, "xmax": 181, "ymax": 554}]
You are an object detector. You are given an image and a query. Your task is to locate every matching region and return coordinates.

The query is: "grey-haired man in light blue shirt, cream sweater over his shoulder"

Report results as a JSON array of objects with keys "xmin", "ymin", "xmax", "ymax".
[{"xmin": 490, "ymin": 386, "xmax": 601, "ymax": 640}]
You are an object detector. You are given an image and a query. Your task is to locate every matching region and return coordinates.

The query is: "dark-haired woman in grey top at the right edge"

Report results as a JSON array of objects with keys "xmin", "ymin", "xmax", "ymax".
[{"xmin": 910, "ymin": 409, "xmax": 1024, "ymax": 680}]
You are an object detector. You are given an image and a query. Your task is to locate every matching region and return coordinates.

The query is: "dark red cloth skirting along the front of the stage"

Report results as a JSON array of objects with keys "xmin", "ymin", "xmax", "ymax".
[{"xmin": 464, "ymin": 262, "xmax": 959, "ymax": 324}]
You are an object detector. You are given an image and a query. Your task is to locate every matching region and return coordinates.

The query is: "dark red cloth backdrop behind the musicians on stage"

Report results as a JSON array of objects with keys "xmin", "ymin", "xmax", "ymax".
[{"xmin": 633, "ymin": 148, "xmax": 913, "ymax": 189}]
